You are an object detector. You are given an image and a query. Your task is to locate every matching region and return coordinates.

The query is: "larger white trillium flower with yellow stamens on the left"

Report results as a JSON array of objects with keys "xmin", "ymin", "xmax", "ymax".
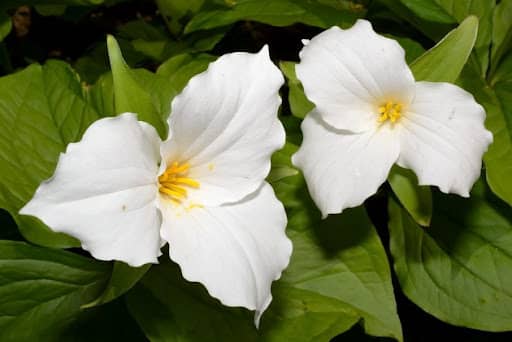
[{"xmin": 20, "ymin": 47, "xmax": 292, "ymax": 324}]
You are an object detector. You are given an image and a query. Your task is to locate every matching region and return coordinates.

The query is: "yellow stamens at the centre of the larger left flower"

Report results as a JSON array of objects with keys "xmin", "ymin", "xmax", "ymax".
[{"xmin": 158, "ymin": 162, "xmax": 199, "ymax": 204}]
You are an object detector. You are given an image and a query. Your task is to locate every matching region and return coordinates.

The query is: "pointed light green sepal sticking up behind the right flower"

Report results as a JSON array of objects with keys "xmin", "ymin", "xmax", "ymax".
[{"xmin": 411, "ymin": 16, "xmax": 478, "ymax": 82}]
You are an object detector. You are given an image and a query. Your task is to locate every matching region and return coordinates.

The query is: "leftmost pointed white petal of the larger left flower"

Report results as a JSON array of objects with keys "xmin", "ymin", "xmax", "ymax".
[{"xmin": 20, "ymin": 113, "xmax": 161, "ymax": 266}]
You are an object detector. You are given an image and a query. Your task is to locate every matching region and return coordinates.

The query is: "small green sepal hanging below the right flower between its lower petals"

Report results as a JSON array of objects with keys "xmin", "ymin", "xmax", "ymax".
[{"xmin": 388, "ymin": 165, "xmax": 432, "ymax": 227}]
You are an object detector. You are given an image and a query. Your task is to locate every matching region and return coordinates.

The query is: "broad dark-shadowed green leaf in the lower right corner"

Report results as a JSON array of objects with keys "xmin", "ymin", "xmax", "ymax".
[{"xmin": 389, "ymin": 183, "xmax": 512, "ymax": 331}]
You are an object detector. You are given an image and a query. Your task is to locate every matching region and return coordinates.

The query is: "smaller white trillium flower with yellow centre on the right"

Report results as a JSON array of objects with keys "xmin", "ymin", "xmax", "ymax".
[{"xmin": 293, "ymin": 20, "xmax": 492, "ymax": 217}]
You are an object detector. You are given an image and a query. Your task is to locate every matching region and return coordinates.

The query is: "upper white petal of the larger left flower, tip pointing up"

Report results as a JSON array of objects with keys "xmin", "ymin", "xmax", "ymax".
[{"xmin": 162, "ymin": 46, "xmax": 285, "ymax": 205}]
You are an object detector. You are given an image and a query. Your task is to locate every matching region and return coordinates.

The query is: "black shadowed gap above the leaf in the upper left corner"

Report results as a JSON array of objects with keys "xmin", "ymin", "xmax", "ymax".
[{"xmin": 0, "ymin": 0, "xmax": 159, "ymax": 74}]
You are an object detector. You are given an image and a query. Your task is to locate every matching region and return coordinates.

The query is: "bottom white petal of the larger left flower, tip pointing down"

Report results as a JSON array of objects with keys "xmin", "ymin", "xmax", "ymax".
[{"xmin": 161, "ymin": 183, "xmax": 292, "ymax": 323}]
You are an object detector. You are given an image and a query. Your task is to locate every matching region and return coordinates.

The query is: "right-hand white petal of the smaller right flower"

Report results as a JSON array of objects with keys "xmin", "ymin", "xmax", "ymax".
[{"xmin": 398, "ymin": 82, "xmax": 492, "ymax": 196}]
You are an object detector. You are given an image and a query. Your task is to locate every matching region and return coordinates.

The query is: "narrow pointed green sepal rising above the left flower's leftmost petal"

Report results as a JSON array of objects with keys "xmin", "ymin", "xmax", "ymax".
[{"xmin": 107, "ymin": 35, "xmax": 167, "ymax": 138}]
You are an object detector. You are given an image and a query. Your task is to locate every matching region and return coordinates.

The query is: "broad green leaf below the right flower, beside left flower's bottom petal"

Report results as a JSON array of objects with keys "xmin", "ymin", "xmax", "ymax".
[{"xmin": 274, "ymin": 172, "xmax": 402, "ymax": 340}]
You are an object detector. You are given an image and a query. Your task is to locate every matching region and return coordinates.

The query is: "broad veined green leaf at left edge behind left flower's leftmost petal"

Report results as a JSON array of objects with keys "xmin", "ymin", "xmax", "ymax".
[{"xmin": 0, "ymin": 61, "xmax": 98, "ymax": 247}]
